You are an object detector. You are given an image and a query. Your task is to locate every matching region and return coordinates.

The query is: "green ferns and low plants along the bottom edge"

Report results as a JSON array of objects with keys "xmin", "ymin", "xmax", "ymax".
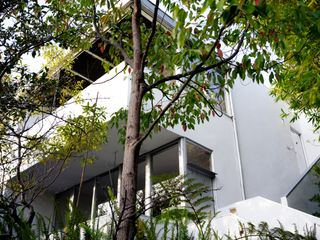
[{"xmin": 0, "ymin": 177, "xmax": 316, "ymax": 240}]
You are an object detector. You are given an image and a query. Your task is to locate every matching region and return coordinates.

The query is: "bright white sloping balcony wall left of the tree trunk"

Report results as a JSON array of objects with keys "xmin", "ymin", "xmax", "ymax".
[{"xmin": 23, "ymin": 62, "xmax": 130, "ymax": 172}]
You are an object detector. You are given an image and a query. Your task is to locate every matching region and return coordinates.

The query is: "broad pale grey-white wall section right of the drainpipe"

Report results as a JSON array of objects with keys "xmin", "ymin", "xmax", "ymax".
[{"xmin": 232, "ymin": 80, "xmax": 308, "ymax": 202}]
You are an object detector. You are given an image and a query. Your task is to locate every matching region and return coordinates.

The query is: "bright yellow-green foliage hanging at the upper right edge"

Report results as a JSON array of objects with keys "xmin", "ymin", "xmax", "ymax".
[{"xmin": 272, "ymin": 1, "xmax": 320, "ymax": 131}]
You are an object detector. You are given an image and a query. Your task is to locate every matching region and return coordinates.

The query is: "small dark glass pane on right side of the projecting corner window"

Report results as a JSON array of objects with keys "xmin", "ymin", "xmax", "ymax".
[{"xmin": 187, "ymin": 142, "xmax": 211, "ymax": 171}]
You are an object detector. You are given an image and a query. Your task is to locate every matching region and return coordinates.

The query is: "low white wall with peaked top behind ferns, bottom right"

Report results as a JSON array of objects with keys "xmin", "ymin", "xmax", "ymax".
[{"xmin": 216, "ymin": 197, "xmax": 320, "ymax": 239}]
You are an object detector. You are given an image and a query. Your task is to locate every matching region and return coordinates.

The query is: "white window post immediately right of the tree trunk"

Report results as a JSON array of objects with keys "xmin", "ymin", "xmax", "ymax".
[{"xmin": 145, "ymin": 154, "xmax": 152, "ymax": 217}]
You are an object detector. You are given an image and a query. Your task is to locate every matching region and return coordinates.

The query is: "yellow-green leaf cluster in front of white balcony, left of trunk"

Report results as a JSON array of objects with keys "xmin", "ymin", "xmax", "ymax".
[{"xmin": 37, "ymin": 103, "xmax": 108, "ymax": 165}]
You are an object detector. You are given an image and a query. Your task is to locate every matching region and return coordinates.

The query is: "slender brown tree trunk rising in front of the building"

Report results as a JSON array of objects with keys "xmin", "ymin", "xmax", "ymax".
[{"xmin": 117, "ymin": 0, "xmax": 145, "ymax": 240}]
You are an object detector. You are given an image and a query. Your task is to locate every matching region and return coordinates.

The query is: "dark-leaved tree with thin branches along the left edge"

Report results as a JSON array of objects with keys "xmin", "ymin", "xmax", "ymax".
[{"xmin": 0, "ymin": 0, "xmax": 107, "ymax": 234}]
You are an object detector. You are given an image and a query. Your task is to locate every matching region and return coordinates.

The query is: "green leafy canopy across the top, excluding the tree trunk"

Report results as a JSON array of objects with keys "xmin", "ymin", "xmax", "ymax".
[{"xmin": 49, "ymin": 0, "xmax": 319, "ymax": 137}]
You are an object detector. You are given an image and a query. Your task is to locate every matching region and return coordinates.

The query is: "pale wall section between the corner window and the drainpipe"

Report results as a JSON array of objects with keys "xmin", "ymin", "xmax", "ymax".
[{"xmin": 173, "ymin": 116, "xmax": 242, "ymax": 208}]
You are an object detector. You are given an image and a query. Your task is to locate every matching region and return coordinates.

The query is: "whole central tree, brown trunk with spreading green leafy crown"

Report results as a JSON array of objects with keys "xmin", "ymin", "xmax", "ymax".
[{"xmin": 2, "ymin": 0, "xmax": 319, "ymax": 239}]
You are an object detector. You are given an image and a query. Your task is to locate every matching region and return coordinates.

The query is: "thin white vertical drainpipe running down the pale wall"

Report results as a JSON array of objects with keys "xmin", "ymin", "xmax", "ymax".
[{"xmin": 228, "ymin": 88, "xmax": 246, "ymax": 200}]
